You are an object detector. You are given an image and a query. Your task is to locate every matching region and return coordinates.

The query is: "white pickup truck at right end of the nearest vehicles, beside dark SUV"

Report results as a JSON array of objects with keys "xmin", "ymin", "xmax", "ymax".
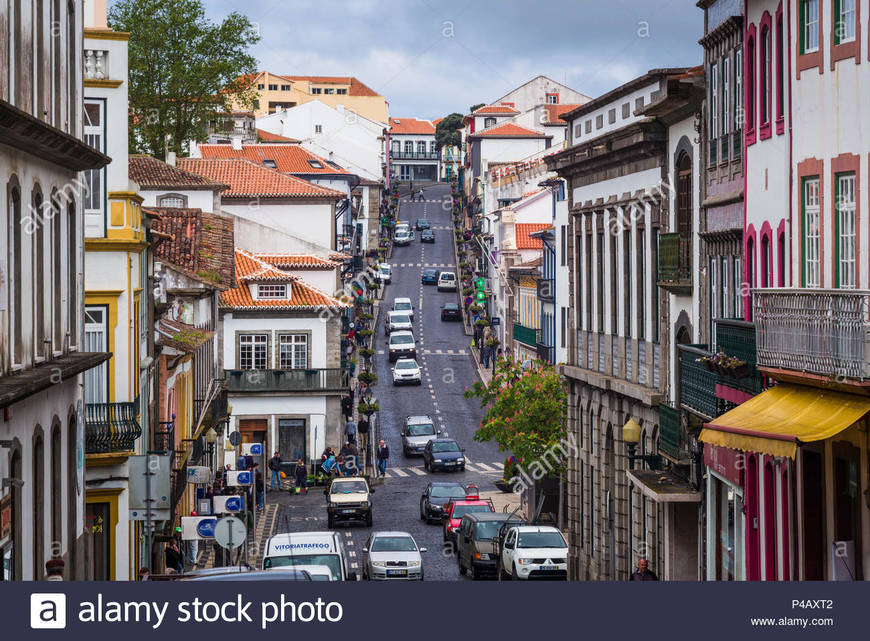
[{"xmin": 499, "ymin": 525, "xmax": 568, "ymax": 581}]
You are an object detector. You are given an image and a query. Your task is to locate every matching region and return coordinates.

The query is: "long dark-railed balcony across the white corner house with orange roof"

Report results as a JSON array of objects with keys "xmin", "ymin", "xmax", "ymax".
[{"xmin": 226, "ymin": 367, "xmax": 350, "ymax": 394}]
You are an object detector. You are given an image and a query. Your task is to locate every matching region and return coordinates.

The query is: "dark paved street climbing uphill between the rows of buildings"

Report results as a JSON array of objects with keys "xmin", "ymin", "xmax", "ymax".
[{"xmin": 270, "ymin": 185, "xmax": 503, "ymax": 580}]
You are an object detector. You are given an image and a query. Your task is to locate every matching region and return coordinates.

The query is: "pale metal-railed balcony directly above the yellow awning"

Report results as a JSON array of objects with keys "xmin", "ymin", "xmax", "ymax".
[{"xmin": 752, "ymin": 289, "xmax": 870, "ymax": 380}]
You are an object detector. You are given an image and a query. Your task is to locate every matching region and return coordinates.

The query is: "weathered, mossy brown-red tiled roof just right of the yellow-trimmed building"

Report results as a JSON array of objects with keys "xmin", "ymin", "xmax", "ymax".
[{"xmin": 145, "ymin": 207, "xmax": 235, "ymax": 289}]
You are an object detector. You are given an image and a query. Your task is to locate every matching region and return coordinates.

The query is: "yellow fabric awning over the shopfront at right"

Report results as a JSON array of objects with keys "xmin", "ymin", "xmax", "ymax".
[{"xmin": 698, "ymin": 385, "xmax": 870, "ymax": 458}]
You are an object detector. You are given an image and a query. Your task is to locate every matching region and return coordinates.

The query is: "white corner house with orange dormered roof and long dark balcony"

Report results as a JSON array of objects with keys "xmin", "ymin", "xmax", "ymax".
[{"xmin": 221, "ymin": 249, "xmax": 349, "ymax": 464}]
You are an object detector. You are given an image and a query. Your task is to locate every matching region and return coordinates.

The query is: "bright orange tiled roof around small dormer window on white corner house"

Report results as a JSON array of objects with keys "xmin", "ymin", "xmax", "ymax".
[{"xmin": 220, "ymin": 248, "xmax": 350, "ymax": 310}]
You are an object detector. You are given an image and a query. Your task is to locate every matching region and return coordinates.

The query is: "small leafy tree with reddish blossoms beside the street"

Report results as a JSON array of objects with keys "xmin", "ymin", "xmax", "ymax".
[{"xmin": 465, "ymin": 358, "xmax": 573, "ymax": 480}]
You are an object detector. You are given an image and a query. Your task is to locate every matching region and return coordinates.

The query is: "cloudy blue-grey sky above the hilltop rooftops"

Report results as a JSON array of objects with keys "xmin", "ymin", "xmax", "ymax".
[{"xmin": 181, "ymin": 0, "xmax": 703, "ymax": 118}]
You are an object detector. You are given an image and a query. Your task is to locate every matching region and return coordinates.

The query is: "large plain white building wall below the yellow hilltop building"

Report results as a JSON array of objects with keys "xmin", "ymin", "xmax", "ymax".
[{"xmin": 257, "ymin": 100, "xmax": 384, "ymax": 181}]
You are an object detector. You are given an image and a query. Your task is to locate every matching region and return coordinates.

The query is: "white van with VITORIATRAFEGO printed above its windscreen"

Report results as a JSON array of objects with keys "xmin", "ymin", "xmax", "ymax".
[{"xmin": 263, "ymin": 532, "xmax": 357, "ymax": 581}]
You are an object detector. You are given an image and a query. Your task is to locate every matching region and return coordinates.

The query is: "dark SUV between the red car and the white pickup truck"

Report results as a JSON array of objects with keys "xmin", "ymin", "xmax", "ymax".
[{"xmin": 456, "ymin": 512, "xmax": 526, "ymax": 580}]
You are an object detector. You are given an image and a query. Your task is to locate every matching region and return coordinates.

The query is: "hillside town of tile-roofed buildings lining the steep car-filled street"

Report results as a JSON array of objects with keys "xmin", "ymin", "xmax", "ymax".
[{"xmin": 0, "ymin": 0, "xmax": 870, "ymax": 581}]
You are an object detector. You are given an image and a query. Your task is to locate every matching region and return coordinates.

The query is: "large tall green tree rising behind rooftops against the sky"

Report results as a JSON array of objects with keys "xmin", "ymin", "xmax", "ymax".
[{"xmin": 109, "ymin": 0, "xmax": 260, "ymax": 158}]
